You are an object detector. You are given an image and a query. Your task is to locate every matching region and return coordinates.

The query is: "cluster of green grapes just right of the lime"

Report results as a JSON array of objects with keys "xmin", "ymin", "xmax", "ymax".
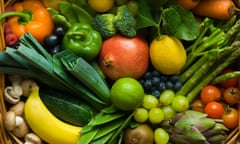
[{"xmin": 133, "ymin": 89, "xmax": 189, "ymax": 124}]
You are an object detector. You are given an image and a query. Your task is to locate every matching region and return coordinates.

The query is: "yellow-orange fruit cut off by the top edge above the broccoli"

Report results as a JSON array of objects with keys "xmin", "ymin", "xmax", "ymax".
[{"xmin": 87, "ymin": 0, "xmax": 114, "ymax": 12}]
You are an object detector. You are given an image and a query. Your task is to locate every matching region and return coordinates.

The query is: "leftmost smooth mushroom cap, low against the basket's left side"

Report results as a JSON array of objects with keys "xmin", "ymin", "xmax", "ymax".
[{"xmin": 3, "ymin": 111, "xmax": 16, "ymax": 131}]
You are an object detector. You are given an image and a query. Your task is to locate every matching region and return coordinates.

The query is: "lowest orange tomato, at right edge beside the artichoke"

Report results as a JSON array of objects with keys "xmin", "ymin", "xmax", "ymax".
[{"xmin": 222, "ymin": 108, "xmax": 239, "ymax": 129}]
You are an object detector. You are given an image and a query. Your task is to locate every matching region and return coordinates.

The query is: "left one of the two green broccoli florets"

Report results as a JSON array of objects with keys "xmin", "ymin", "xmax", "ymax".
[{"xmin": 92, "ymin": 13, "xmax": 117, "ymax": 38}]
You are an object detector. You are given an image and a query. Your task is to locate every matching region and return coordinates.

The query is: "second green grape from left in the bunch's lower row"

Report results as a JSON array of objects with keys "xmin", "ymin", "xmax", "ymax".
[{"xmin": 148, "ymin": 107, "xmax": 164, "ymax": 124}]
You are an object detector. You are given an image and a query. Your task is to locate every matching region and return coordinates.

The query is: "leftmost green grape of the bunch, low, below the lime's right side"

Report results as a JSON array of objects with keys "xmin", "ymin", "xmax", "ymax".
[{"xmin": 133, "ymin": 108, "xmax": 148, "ymax": 123}]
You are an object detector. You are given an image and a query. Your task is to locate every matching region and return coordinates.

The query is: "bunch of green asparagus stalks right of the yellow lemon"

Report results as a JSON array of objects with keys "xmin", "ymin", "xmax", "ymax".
[{"xmin": 176, "ymin": 16, "xmax": 240, "ymax": 102}]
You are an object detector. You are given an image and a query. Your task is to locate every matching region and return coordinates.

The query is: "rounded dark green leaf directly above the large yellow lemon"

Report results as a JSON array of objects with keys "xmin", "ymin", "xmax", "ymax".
[{"xmin": 162, "ymin": 7, "xmax": 181, "ymax": 35}]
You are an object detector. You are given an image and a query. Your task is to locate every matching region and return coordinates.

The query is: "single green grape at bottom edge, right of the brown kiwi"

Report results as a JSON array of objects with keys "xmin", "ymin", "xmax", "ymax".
[{"xmin": 154, "ymin": 128, "xmax": 169, "ymax": 144}]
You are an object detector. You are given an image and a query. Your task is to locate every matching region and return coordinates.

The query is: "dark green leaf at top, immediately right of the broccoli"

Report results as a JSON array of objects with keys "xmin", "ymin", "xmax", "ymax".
[{"xmin": 136, "ymin": 0, "xmax": 157, "ymax": 29}]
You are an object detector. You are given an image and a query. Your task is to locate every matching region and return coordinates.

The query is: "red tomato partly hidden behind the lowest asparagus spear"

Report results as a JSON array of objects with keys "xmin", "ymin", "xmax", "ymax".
[{"xmin": 219, "ymin": 68, "xmax": 238, "ymax": 88}]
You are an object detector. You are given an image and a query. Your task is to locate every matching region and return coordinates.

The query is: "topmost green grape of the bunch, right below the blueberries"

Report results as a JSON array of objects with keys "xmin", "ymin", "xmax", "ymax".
[{"xmin": 159, "ymin": 89, "xmax": 175, "ymax": 105}]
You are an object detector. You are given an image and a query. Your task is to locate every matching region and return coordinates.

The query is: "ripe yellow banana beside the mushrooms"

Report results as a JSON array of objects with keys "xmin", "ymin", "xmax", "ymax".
[{"xmin": 24, "ymin": 86, "xmax": 82, "ymax": 144}]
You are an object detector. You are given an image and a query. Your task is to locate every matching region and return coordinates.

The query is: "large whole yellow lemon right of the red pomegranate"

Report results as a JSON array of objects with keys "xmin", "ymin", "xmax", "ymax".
[{"xmin": 150, "ymin": 35, "xmax": 187, "ymax": 75}]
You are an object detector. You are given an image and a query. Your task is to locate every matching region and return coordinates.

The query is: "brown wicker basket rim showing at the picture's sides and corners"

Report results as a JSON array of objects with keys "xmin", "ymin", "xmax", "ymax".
[{"xmin": 0, "ymin": 0, "xmax": 240, "ymax": 144}]
